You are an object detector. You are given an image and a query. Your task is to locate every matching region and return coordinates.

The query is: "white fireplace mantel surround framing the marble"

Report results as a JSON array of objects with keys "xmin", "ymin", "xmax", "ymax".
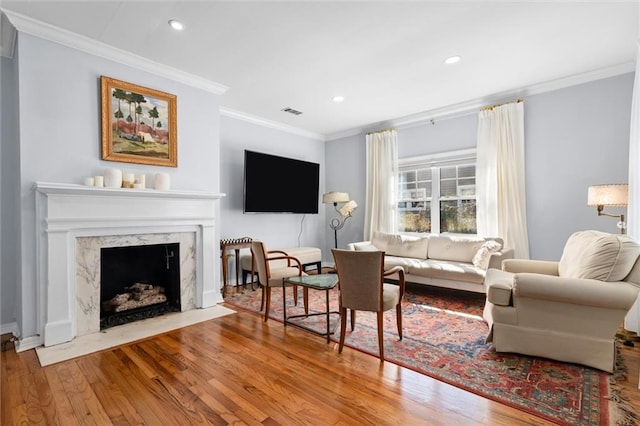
[{"xmin": 34, "ymin": 182, "xmax": 225, "ymax": 346}]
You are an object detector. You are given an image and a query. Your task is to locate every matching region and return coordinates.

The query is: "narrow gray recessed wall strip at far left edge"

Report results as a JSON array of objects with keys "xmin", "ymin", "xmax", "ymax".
[{"xmin": 0, "ymin": 53, "xmax": 20, "ymax": 334}]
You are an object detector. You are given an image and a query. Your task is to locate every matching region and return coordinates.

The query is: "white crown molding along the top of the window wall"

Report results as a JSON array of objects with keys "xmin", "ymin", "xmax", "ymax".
[{"xmin": 326, "ymin": 62, "xmax": 636, "ymax": 141}]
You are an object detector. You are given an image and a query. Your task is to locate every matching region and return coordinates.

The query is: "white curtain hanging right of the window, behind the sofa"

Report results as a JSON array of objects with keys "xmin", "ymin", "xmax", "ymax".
[{"xmin": 476, "ymin": 101, "xmax": 529, "ymax": 259}]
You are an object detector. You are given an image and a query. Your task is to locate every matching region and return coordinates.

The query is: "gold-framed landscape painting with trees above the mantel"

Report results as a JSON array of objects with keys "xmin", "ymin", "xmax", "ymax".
[{"xmin": 100, "ymin": 76, "xmax": 178, "ymax": 167}]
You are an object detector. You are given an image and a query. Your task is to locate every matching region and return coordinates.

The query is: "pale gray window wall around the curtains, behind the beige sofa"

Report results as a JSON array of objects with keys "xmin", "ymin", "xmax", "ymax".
[{"xmin": 325, "ymin": 73, "xmax": 633, "ymax": 260}]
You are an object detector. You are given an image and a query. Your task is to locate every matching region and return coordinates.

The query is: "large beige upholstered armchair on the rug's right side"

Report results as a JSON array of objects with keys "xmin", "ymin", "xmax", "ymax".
[{"xmin": 483, "ymin": 231, "xmax": 640, "ymax": 372}]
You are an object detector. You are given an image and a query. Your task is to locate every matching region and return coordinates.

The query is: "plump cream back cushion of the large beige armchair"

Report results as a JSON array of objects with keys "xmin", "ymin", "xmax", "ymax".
[{"xmin": 558, "ymin": 231, "xmax": 640, "ymax": 281}]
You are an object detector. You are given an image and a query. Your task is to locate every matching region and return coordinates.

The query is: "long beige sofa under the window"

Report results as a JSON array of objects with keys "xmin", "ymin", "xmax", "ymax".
[{"xmin": 347, "ymin": 232, "xmax": 513, "ymax": 293}]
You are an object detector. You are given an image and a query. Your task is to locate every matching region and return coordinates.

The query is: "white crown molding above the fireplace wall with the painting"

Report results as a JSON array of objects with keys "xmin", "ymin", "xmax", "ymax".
[{"xmin": 2, "ymin": 10, "xmax": 229, "ymax": 95}]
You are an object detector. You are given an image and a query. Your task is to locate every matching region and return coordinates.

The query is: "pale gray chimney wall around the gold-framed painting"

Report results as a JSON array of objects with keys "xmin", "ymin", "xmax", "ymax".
[{"xmin": 2, "ymin": 33, "xmax": 220, "ymax": 337}]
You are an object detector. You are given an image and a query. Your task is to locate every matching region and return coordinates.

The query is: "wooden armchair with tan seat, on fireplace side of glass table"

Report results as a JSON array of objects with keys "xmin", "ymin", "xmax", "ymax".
[{"xmin": 251, "ymin": 241, "xmax": 309, "ymax": 321}]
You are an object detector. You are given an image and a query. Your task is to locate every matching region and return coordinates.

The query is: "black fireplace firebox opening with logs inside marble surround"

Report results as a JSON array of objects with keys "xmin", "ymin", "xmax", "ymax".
[{"xmin": 100, "ymin": 243, "xmax": 180, "ymax": 330}]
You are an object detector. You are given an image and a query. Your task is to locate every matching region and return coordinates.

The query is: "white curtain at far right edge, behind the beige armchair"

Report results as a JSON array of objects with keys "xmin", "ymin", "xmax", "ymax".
[{"xmin": 624, "ymin": 40, "xmax": 640, "ymax": 333}]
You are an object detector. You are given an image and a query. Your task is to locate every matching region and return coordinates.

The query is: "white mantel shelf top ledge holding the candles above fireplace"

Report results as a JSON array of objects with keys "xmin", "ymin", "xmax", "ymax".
[{"xmin": 34, "ymin": 182, "xmax": 226, "ymax": 199}]
